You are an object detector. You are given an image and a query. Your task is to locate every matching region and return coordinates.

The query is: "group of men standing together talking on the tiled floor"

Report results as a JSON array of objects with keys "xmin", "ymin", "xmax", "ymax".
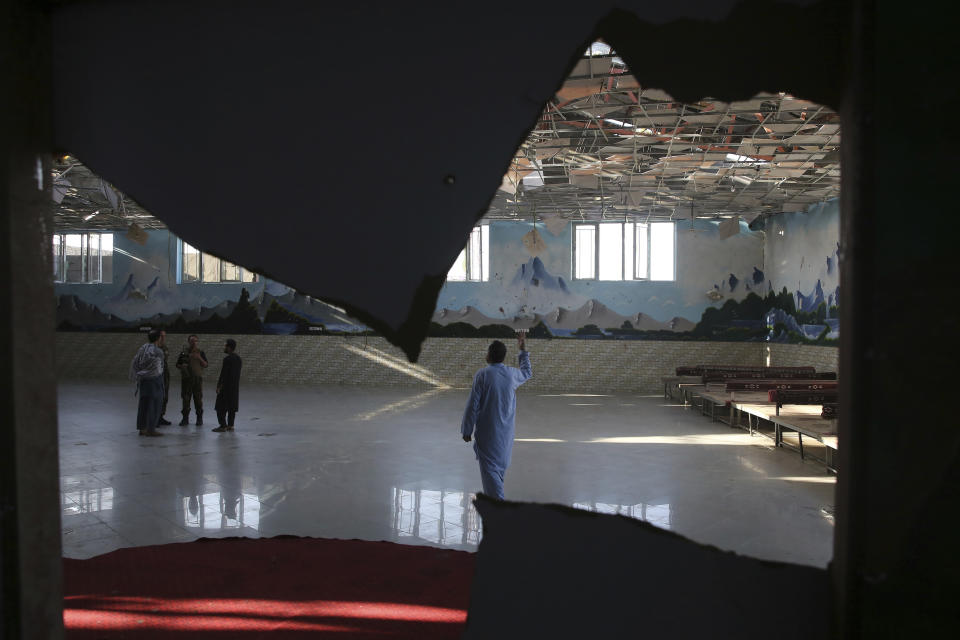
[{"xmin": 129, "ymin": 329, "xmax": 242, "ymax": 437}]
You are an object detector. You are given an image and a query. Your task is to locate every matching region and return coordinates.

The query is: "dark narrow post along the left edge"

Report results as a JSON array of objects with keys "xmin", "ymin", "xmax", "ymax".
[{"xmin": 0, "ymin": 0, "xmax": 63, "ymax": 640}]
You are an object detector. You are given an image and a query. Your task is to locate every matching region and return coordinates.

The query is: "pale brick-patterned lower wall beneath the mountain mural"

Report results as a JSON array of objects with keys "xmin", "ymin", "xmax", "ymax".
[{"xmin": 57, "ymin": 332, "xmax": 764, "ymax": 393}]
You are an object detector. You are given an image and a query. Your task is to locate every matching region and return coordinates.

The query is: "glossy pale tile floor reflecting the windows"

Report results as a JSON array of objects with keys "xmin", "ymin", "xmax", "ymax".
[{"xmin": 59, "ymin": 384, "xmax": 834, "ymax": 567}]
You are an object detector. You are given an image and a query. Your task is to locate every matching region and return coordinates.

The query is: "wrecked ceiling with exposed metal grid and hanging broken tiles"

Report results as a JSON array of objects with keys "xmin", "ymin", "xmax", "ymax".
[{"xmin": 53, "ymin": 42, "xmax": 840, "ymax": 229}]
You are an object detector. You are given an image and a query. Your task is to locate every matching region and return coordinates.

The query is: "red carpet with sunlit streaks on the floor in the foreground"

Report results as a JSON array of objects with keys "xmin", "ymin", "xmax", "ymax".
[{"xmin": 63, "ymin": 536, "xmax": 474, "ymax": 640}]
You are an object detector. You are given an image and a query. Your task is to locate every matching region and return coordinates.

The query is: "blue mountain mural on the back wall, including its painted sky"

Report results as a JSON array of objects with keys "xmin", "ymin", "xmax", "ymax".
[{"xmin": 55, "ymin": 210, "xmax": 840, "ymax": 344}]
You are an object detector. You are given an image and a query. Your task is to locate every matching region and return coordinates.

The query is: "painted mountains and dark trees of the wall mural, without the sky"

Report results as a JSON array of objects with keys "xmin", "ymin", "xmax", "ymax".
[{"xmin": 57, "ymin": 258, "xmax": 839, "ymax": 344}]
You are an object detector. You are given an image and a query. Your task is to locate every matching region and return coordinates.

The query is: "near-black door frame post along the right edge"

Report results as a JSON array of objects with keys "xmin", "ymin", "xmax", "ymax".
[{"xmin": 833, "ymin": 0, "xmax": 960, "ymax": 639}]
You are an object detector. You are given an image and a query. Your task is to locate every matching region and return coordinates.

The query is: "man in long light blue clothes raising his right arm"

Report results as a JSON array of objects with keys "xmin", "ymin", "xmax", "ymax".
[{"xmin": 460, "ymin": 331, "xmax": 533, "ymax": 500}]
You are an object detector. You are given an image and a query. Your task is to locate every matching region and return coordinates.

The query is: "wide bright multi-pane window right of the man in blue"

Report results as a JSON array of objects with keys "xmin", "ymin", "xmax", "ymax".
[{"xmin": 573, "ymin": 222, "xmax": 676, "ymax": 281}]
